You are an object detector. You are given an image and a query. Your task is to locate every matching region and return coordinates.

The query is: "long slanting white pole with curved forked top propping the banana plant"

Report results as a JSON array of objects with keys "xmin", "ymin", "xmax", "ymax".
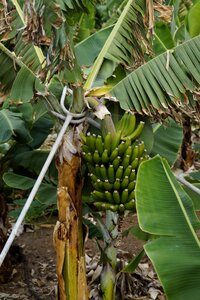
[{"xmin": 0, "ymin": 86, "xmax": 86, "ymax": 267}]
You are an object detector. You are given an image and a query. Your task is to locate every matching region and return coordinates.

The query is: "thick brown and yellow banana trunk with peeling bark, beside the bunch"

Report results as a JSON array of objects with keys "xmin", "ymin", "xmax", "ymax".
[{"xmin": 54, "ymin": 132, "xmax": 88, "ymax": 300}]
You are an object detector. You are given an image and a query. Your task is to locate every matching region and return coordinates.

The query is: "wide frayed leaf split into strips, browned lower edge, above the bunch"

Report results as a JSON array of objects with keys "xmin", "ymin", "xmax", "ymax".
[{"xmin": 110, "ymin": 36, "xmax": 200, "ymax": 115}]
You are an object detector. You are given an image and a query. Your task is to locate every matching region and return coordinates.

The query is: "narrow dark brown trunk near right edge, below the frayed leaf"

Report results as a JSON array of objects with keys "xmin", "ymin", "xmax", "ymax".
[{"xmin": 181, "ymin": 116, "xmax": 194, "ymax": 171}]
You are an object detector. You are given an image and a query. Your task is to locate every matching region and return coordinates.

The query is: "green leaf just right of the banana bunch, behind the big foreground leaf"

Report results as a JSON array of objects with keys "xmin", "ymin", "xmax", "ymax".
[{"xmin": 151, "ymin": 119, "xmax": 183, "ymax": 165}]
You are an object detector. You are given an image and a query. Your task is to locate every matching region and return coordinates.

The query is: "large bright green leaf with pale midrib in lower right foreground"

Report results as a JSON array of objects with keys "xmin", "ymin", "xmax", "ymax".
[{"xmin": 136, "ymin": 156, "xmax": 200, "ymax": 300}]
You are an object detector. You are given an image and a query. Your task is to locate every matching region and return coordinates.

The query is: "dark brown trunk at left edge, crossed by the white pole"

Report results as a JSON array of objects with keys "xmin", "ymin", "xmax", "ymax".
[{"xmin": 0, "ymin": 195, "xmax": 13, "ymax": 283}]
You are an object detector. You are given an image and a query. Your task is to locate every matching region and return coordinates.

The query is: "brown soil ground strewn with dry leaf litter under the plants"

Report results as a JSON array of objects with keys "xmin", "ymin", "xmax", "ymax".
[{"xmin": 0, "ymin": 216, "xmax": 165, "ymax": 300}]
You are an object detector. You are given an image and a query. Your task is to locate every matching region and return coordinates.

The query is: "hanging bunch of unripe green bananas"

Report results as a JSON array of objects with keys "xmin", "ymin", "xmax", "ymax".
[{"xmin": 82, "ymin": 113, "xmax": 148, "ymax": 213}]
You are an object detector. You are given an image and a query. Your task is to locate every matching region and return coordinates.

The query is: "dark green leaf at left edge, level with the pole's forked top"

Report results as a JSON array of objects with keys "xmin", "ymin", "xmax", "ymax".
[{"xmin": 0, "ymin": 109, "xmax": 32, "ymax": 143}]
